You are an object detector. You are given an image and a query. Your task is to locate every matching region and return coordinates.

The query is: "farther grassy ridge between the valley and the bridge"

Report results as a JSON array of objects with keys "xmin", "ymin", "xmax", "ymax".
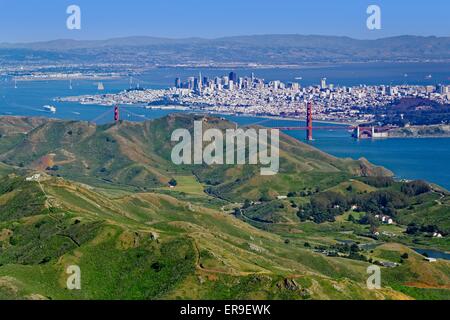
[{"xmin": 0, "ymin": 115, "xmax": 389, "ymax": 200}]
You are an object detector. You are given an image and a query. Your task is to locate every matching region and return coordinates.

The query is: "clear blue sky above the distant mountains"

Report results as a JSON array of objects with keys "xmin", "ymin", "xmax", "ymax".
[{"xmin": 0, "ymin": 0, "xmax": 450, "ymax": 42}]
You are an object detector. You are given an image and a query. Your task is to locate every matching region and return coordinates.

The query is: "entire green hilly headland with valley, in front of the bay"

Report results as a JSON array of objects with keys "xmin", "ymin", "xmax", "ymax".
[{"xmin": 0, "ymin": 115, "xmax": 450, "ymax": 299}]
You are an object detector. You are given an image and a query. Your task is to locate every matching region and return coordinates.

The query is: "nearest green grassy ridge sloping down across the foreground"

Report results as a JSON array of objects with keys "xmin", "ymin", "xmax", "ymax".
[{"xmin": 0, "ymin": 170, "xmax": 432, "ymax": 299}]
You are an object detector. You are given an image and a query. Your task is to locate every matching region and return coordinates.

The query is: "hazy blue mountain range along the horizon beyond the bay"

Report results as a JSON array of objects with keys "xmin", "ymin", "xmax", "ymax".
[{"xmin": 0, "ymin": 35, "xmax": 450, "ymax": 65}]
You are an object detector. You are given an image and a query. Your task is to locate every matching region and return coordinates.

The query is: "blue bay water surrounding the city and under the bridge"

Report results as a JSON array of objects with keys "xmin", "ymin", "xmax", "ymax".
[{"xmin": 0, "ymin": 64, "xmax": 450, "ymax": 189}]
